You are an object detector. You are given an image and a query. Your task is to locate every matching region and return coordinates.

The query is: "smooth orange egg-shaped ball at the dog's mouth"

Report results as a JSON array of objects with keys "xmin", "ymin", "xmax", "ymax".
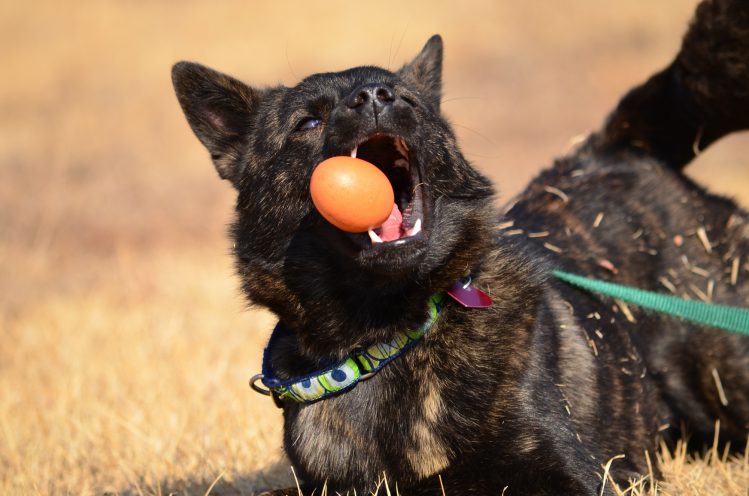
[{"xmin": 309, "ymin": 156, "xmax": 394, "ymax": 232}]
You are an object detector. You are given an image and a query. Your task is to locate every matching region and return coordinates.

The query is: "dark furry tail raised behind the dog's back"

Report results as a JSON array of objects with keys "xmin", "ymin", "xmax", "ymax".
[{"xmin": 596, "ymin": 0, "xmax": 749, "ymax": 170}]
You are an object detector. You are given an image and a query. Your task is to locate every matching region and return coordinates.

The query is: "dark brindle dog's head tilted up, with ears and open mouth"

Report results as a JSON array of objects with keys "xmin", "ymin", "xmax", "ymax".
[{"xmin": 172, "ymin": 36, "xmax": 493, "ymax": 348}]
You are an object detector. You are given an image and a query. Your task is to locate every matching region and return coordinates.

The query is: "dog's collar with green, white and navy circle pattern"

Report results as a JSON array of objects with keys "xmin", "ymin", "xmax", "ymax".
[{"xmin": 250, "ymin": 293, "xmax": 445, "ymax": 404}]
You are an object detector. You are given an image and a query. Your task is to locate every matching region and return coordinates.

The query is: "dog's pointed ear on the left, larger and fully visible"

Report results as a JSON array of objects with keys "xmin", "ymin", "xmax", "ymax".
[{"xmin": 172, "ymin": 62, "xmax": 260, "ymax": 182}]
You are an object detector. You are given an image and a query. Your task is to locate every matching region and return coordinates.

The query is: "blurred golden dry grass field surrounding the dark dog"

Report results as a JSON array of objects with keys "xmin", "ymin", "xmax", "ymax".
[{"xmin": 0, "ymin": 0, "xmax": 749, "ymax": 496}]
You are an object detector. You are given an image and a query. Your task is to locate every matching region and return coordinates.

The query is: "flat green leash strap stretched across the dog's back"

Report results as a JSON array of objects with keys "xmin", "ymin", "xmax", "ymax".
[{"xmin": 552, "ymin": 270, "xmax": 749, "ymax": 336}]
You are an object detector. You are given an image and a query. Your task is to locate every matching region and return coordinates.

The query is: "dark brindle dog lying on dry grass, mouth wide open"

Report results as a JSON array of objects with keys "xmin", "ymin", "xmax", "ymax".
[{"xmin": 173, "ymin": 0, "xmax": 749, "ymax": 496}]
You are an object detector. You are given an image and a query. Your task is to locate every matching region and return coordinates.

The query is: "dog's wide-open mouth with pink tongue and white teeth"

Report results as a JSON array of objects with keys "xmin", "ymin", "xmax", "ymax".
[{"xmin": 351, "ymin": 134, "xmax": 425, "ymax": 246}]
